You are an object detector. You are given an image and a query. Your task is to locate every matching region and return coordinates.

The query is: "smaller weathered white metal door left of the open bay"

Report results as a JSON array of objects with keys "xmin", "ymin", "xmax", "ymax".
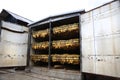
[{"xmin": 0, "ymin": 23, "xmax": 28, "ymax": 67}]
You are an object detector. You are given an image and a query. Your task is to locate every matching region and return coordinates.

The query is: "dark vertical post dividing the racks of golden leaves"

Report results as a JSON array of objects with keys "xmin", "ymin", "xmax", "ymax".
[{"xmin": 48, "ymin": 19, "xmax": 52, "ymax": 69}]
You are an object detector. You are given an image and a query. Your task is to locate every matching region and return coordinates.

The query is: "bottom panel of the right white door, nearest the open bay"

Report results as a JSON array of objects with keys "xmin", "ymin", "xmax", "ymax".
[{"xmin": 82, "ymin": 56, "xmax": 95, "ymax": 73}]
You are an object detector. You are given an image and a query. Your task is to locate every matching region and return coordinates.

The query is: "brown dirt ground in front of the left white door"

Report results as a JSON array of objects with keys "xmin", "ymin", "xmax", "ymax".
[{"xmin": 0, "ymin": 70, "xmax": 62, "ymax": 80}]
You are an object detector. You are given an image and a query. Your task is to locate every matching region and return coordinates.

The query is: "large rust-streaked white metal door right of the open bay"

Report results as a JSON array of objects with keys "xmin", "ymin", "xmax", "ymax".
[{"xmin": 81, "ymin": 1, "xmax": 120, "ymax": 77}]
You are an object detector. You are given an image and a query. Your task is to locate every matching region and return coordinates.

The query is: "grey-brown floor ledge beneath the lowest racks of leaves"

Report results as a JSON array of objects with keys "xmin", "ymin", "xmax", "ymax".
[{"xmin": 31, "ymin": 67, "xmax": 81, "ymax": 80}]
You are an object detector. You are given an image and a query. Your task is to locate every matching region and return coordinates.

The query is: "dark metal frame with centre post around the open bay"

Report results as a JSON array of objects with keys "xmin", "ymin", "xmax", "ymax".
[{"xmin": 28, "ymin": 12, "xmax": 82, "ymax": 79}]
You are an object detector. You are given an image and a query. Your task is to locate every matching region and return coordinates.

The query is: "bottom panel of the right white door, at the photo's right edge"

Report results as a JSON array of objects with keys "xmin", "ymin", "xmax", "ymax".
[{"xmin": 96, "ymin": 56, "xmax": 120, "ymax": 77}]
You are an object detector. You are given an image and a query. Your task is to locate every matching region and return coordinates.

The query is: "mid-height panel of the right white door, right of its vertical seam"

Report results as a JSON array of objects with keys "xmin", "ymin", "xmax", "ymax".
[{"xmin": 95, "ymin": 36, "xmax": 114, "ymax": 56}]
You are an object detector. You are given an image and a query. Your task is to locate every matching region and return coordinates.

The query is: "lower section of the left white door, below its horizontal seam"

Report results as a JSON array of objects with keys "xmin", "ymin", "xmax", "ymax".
[{"xmin": 0, "ymin": 42, "xmax": 27, "ymax": 67}]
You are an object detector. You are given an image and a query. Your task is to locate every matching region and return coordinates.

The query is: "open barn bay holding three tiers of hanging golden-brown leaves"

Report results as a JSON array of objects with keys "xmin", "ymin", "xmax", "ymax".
[{"xmin": 28, "ymin": 10, "xmax": 84, "ymax": 80}]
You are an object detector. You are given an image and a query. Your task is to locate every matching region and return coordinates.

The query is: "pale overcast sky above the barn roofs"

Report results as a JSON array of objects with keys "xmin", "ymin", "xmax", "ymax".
[{"xmin": 0, "ymin": 0, "xmax": 112, "ymax": 21}]
